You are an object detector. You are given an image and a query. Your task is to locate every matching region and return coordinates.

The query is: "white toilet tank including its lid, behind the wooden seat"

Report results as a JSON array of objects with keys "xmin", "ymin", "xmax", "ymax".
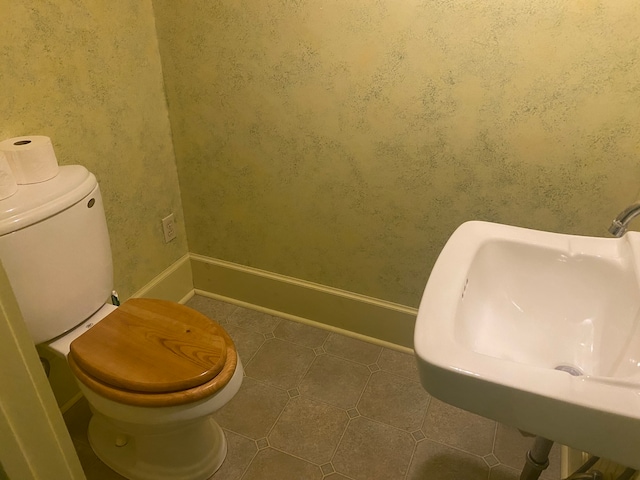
[{"xmin": 0, "ymin": 165, "xmax": 113, "ymax": 344}]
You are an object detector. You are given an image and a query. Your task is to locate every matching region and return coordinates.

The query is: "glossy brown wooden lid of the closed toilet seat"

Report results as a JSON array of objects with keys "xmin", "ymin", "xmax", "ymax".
[{"xmin": 69, "ymin": 298, "xmax": 227, "ymax": 393}]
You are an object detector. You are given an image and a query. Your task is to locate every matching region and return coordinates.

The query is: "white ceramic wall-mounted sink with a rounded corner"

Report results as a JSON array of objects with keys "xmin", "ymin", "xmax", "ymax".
[{"xmin": 414, "ymin": 222, "xmax": 640, "ymax": 469}]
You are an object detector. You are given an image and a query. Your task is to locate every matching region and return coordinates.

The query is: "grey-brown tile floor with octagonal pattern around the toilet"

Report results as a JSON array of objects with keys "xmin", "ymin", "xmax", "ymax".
[{"xmin": 65, "ymin": 296, "xmax": 560, "ymax": 480}]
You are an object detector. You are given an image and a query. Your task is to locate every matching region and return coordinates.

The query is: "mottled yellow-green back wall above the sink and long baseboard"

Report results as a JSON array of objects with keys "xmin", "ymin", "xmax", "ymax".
[{"xmin": 155, "ymin": 0, "xmax": 640, "ymax": 306}]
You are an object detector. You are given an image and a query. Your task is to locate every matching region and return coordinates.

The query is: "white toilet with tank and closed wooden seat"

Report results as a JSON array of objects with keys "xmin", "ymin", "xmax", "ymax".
[{"xmin": 0, "ymin": 165, "xmax": 243, "ymax": 480}]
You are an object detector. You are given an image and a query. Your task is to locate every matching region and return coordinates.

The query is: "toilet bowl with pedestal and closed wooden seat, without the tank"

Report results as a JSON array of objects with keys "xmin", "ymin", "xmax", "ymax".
[{"xmin": 47, "ymin": 298, "xmax": 243, "ymax": 480}]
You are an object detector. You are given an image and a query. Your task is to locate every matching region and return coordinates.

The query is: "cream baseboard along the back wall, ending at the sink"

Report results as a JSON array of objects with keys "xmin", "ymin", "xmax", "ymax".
[{"xmin": 189, "ymin": 254, "xmax": 417, "ymax": 349}]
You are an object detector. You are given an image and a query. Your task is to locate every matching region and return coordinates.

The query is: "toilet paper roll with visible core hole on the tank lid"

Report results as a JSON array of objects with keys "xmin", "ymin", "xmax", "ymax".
[{"xmin": 0, "ymin": 135, "xmax": 58, "ymax": 185}]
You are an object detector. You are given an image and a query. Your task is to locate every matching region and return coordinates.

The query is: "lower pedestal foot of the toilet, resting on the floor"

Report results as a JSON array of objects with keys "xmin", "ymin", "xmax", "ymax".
[{"xmin": 89, "ymin": 412, "xmax": 227, "ymax": 480}]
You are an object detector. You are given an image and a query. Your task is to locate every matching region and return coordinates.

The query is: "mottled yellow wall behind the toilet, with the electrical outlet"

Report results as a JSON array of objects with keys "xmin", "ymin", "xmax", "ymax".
[{"xmin": 0, "ymin": 0, "xmax": 187, "ymax": 297}]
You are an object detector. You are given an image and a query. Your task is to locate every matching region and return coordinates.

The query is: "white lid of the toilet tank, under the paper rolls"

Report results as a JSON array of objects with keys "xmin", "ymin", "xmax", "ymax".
[{"xmin": 0, "ymin": 165, "xmax": 98, "ymax": 236}]
